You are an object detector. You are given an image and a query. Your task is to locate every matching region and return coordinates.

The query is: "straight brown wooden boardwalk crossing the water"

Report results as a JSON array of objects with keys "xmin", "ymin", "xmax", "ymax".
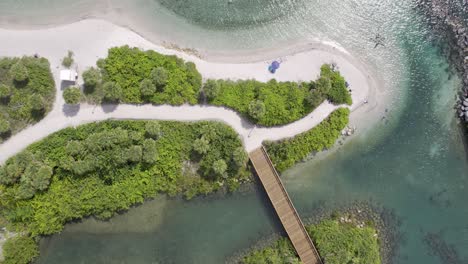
[{"xmin": 249, "ymin": 147, "xmax": 322, "ymax": 264}]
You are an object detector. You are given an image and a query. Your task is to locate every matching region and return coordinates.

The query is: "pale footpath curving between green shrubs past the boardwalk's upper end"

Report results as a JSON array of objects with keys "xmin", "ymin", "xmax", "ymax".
[{"xmin": 0, "ymin": 102, "xmax": 338, "ymax": 164}]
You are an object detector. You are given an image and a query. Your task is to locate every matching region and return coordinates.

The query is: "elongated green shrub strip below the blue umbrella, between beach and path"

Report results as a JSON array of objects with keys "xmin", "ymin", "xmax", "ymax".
[{"xmin": 203, "ymin": 64, "xmax": 352, "ymax": 126}]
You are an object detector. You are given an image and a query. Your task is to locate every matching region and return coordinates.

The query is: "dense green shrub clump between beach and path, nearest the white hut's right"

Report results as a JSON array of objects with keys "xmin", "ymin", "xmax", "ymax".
[{"xmin": 83, "ymin": 46, "xmax": 202, "ymax": 105}]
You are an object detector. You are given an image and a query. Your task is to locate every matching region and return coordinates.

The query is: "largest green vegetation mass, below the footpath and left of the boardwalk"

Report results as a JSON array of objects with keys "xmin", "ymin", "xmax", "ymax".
[{"xmin": 0, "ymin": 121, "xmax": 250, "ymax": 264}]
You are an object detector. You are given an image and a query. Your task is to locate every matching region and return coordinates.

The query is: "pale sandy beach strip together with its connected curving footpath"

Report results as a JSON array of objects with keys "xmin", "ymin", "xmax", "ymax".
[{"xmin": 0, "ymin": 20, "xmax": 376, "ymax": 164}]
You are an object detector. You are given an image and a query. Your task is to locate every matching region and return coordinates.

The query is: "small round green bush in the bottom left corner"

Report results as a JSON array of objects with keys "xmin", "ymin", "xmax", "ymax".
[{"xmin": 3, "ymin": 235, "xmax": 39, "ymax": 264}]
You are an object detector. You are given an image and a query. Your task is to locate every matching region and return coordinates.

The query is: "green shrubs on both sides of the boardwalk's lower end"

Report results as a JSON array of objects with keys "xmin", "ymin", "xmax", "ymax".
[{"xmin": 241, "ymin": 220, "xmax": 381, "ymax": 264}]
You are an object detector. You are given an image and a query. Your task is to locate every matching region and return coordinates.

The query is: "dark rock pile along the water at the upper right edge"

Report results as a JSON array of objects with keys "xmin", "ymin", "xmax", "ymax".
[{"xmin": 418, "ymin": 0, "xmax": 468, "ymax": 119}]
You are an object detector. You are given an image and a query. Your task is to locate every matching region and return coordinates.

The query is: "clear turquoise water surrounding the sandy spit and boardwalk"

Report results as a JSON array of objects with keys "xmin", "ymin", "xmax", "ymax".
[{"xmin": 0, "ymin": 0, "xmax": 468, "ymax": 264}]
